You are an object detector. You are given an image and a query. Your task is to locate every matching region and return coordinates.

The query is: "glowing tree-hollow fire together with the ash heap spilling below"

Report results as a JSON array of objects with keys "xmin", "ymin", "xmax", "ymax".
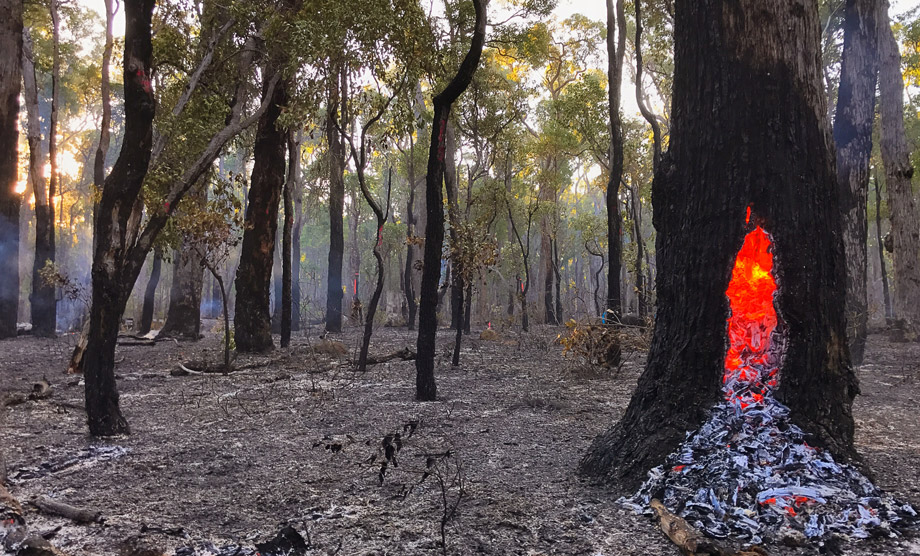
[{"xmin": 620, "ymin": 213, "xmax": 917, "ymax": 545}]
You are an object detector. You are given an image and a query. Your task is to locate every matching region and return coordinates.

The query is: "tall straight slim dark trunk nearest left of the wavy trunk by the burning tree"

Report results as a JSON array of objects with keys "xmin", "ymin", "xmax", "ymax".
[{"xmin": 607, "ymin": 0, "xmax": 626, "ymax": 319}]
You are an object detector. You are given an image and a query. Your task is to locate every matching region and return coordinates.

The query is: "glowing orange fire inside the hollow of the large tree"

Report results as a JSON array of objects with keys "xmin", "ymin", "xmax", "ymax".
[{"xmin": 722, "ymin": 215, "xmax": 778, "ymax": 410}]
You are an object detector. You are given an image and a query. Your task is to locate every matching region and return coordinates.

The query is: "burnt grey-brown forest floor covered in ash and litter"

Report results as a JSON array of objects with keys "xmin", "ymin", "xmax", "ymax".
[{"xmin": 0, "ymin": 321, "xmax": 920, "ymax": 556}]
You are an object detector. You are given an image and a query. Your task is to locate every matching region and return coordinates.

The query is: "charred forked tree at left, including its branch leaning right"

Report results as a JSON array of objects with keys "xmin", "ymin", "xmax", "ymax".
[{"xmin": 83, "ymin": 0, "xmax": 278, "ymax": 436}]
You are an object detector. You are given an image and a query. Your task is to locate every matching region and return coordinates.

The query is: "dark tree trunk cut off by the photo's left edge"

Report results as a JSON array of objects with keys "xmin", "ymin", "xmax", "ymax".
[{"xmin": 0, "ymin": 0, "xmax": 22, "ymax": 339}]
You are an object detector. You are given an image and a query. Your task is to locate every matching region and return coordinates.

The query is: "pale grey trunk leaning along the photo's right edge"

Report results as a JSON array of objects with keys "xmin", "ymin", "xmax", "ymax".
[{"xmin": 878, "ymin": 0, "xmax": 920, "ymax": 333}]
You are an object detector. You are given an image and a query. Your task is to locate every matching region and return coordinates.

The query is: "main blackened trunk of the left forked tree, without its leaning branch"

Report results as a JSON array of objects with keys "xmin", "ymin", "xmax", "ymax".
[{"xmin": 83, "ymin": 0, "xmax": 155, "ymax": 436}]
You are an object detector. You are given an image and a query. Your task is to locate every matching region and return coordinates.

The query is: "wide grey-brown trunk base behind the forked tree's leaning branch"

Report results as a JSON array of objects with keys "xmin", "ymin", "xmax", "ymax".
[{"xmin": 160, "ymin": 179, "xmax": 208, "ymax": 342}]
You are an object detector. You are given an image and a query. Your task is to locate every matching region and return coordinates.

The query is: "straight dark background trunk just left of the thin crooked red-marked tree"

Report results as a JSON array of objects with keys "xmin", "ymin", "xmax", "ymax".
[{"xmin": 326, "ymin": 66, "xmax": 347, "ymax": 332}]
